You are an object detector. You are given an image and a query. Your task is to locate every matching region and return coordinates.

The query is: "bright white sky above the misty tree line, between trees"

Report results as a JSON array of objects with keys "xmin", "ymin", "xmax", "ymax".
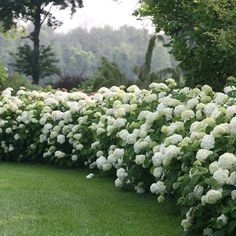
[{"xmin": 53, "ymin": 0, "xmax": 152, "ymax": 32}]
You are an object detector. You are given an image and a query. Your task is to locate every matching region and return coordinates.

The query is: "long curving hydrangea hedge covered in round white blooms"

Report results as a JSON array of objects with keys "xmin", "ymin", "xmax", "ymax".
[{"xmin": 0, "ymin": 79, "xmax": 236, "ymax": 235}]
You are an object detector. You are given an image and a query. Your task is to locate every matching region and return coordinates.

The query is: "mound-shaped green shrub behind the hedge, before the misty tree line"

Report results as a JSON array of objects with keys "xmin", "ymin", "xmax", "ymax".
[{"xmin": 93, "ymin": 57, "xmax": 127, "ymax": 91}]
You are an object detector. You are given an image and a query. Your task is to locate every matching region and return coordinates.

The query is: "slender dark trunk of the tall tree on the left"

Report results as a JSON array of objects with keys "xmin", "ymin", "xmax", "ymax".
[{"xmin": 32, "ymin": 5, "xmax": 41, "ymax": 84}]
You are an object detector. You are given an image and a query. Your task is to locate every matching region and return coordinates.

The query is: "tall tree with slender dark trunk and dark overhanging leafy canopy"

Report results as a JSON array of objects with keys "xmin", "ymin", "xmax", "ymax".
[{"xmin": 0, "ymin": 0, "xmax": 83, "ymax": 84}]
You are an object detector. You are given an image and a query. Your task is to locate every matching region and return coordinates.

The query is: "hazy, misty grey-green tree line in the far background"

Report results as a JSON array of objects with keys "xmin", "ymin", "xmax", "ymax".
[{"xmin": 0, "ymin": 26, "xmax": 176, "ymax": 84}]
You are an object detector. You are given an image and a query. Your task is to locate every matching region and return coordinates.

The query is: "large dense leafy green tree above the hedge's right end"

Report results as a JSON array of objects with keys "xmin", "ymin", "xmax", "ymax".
[{"xmin": 136, "ymin": 0, "xmax": 236, "ymax": 90}]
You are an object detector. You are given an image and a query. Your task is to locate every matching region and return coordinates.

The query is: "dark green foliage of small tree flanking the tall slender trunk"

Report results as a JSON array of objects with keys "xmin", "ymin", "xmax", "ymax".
[{"xmin": 15, "ymin": 44, "xmax": 60, "ymax": 79}]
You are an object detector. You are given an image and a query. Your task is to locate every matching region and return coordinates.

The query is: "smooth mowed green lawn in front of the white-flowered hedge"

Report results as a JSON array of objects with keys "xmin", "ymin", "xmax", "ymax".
[{"xmin": 0, "ymin": 163, "xmax": 183, "ymax": 236}]
